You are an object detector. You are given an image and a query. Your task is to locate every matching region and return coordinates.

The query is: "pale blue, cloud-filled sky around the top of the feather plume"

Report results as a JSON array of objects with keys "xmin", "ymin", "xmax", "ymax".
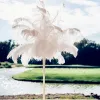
[{"xmin": 0, "ymin": 0, "xmax": 100, "ymax": 43}]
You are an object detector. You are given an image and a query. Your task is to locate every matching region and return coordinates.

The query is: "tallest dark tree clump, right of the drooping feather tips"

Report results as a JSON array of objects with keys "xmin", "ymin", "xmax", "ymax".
[{"xmin": 76, "ymin": 39, "xmax": 100, "ymax": 65}]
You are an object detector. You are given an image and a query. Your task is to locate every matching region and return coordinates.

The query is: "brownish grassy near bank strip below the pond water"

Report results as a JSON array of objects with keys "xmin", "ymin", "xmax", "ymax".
[{"xmin": 0, "ymin": 93, "xmax": 100, "ymax": 100}]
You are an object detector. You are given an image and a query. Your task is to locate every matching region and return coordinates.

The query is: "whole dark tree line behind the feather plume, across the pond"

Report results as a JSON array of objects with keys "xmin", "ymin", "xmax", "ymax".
[{"xmin": 0, "ymin": 38, "xmax": 100, "ymax": 66}]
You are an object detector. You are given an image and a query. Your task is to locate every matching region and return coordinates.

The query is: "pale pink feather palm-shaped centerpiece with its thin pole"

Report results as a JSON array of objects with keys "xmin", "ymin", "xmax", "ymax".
[{"xmin": 8, "ymin": 1, "xmax": 80, "ymax": 100}]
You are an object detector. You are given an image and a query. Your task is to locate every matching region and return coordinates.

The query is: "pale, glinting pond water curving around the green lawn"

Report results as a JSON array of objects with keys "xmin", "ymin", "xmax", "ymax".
[{"xmin": 0, "ymin": 67, "xmax": 100, "ymax": 95}]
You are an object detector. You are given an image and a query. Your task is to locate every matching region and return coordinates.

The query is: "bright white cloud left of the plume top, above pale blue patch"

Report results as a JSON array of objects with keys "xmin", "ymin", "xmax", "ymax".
[{"xmin": 0, "ymin": 2, "xmax": 34, "ymax": 22}]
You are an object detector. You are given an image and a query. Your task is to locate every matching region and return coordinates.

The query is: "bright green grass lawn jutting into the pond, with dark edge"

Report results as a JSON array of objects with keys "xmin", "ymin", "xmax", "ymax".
[{"xmin": 13, "ymin": 68, "xmax": 100, "ymax": 83}]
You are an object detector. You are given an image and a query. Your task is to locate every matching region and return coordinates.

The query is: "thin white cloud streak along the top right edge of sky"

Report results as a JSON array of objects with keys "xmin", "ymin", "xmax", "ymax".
[{"xmin": 66, "ymin": 0, "xmax": 98, "ymax": 6}]
